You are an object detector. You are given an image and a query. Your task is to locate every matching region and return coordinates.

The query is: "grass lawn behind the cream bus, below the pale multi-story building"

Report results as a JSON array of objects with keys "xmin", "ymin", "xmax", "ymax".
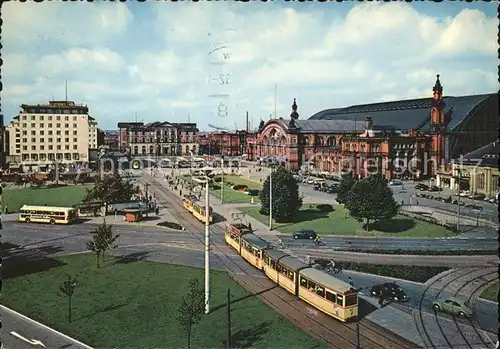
[{"xmin": 2, "ymin": 184, "xmax": 92, "ymax": 213}]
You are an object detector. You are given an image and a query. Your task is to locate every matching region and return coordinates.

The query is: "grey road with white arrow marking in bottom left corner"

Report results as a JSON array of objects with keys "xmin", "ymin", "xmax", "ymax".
[{"xmin": 0, "ymin": 306, "xmax": 90, "ymax": 349}]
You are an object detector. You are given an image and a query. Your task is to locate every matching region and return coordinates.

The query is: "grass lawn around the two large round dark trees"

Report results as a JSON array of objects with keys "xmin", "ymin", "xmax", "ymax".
[{"xmin": 238, "ymin": 205, "xmax": 455, "ymax": 238}]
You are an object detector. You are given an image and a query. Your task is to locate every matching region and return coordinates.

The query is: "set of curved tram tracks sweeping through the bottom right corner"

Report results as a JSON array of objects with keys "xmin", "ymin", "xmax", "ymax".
[{"xmin": 414, "ymin": 267, "xmax": 497, "ymax": 349}]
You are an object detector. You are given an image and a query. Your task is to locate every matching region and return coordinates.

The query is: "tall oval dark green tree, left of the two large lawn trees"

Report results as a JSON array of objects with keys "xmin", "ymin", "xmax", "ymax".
[{"xmin": 259, "ymin": 166, "xmax": 302, "ymax": 222}]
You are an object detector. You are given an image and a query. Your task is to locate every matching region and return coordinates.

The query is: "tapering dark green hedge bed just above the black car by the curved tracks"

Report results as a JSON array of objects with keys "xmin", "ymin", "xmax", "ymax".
[{"xmin": 338, "ymin": 262, "xmax": 450, "ymax": 282}]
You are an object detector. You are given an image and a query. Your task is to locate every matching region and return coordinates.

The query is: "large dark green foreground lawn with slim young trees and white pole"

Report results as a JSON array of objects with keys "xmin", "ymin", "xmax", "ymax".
[{"xmin": 2, "ymin": 254, "xmax": 323, "ymax": 348}]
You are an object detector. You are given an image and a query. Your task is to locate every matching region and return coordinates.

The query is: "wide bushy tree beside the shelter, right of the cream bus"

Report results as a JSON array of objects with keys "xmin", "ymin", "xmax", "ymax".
[{"xmin": 83, "ymin": 173, "xmax": 135, "ymax": 214}]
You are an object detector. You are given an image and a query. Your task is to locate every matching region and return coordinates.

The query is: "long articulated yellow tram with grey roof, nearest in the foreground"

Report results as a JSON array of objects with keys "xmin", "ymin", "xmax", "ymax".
[{"xmin": 225, "ymin": 225, "xmax": 358, "ymax": 322}]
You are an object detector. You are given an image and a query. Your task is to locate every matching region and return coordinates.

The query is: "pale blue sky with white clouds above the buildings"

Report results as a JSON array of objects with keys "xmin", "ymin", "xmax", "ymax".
[{"xmin": 1, "ymin": 1, "xmax": 499, "ymax": 130}]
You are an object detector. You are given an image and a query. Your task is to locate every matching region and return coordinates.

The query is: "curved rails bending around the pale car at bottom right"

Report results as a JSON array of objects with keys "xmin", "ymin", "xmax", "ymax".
[{"xmin": 414, "ymin": 267, "xmax": 498, "ymax": 349}]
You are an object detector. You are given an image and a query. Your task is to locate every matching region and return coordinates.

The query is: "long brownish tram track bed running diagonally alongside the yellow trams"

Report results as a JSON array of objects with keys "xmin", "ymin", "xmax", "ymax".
[{"xmin": 141, "ymin": 178, "xmax": 418, "ymax": 349}]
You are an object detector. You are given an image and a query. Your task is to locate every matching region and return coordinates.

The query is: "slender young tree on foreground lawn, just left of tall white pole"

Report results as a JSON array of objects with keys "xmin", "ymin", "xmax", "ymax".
[{"xmin": 177, "ymin": 279, "xmax": 205, "ymax": 348}]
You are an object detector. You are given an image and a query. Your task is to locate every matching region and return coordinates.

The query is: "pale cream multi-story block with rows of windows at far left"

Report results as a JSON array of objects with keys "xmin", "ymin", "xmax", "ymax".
[{"xmin": 7, "ymin": 101, "xmax": 98, "ymax": 171}]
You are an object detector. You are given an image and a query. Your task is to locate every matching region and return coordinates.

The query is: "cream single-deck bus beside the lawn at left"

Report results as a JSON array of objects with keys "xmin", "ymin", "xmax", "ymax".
[{"xmin": 19, "ymin": 205, "xmax": 77, "ymax": 224}]
